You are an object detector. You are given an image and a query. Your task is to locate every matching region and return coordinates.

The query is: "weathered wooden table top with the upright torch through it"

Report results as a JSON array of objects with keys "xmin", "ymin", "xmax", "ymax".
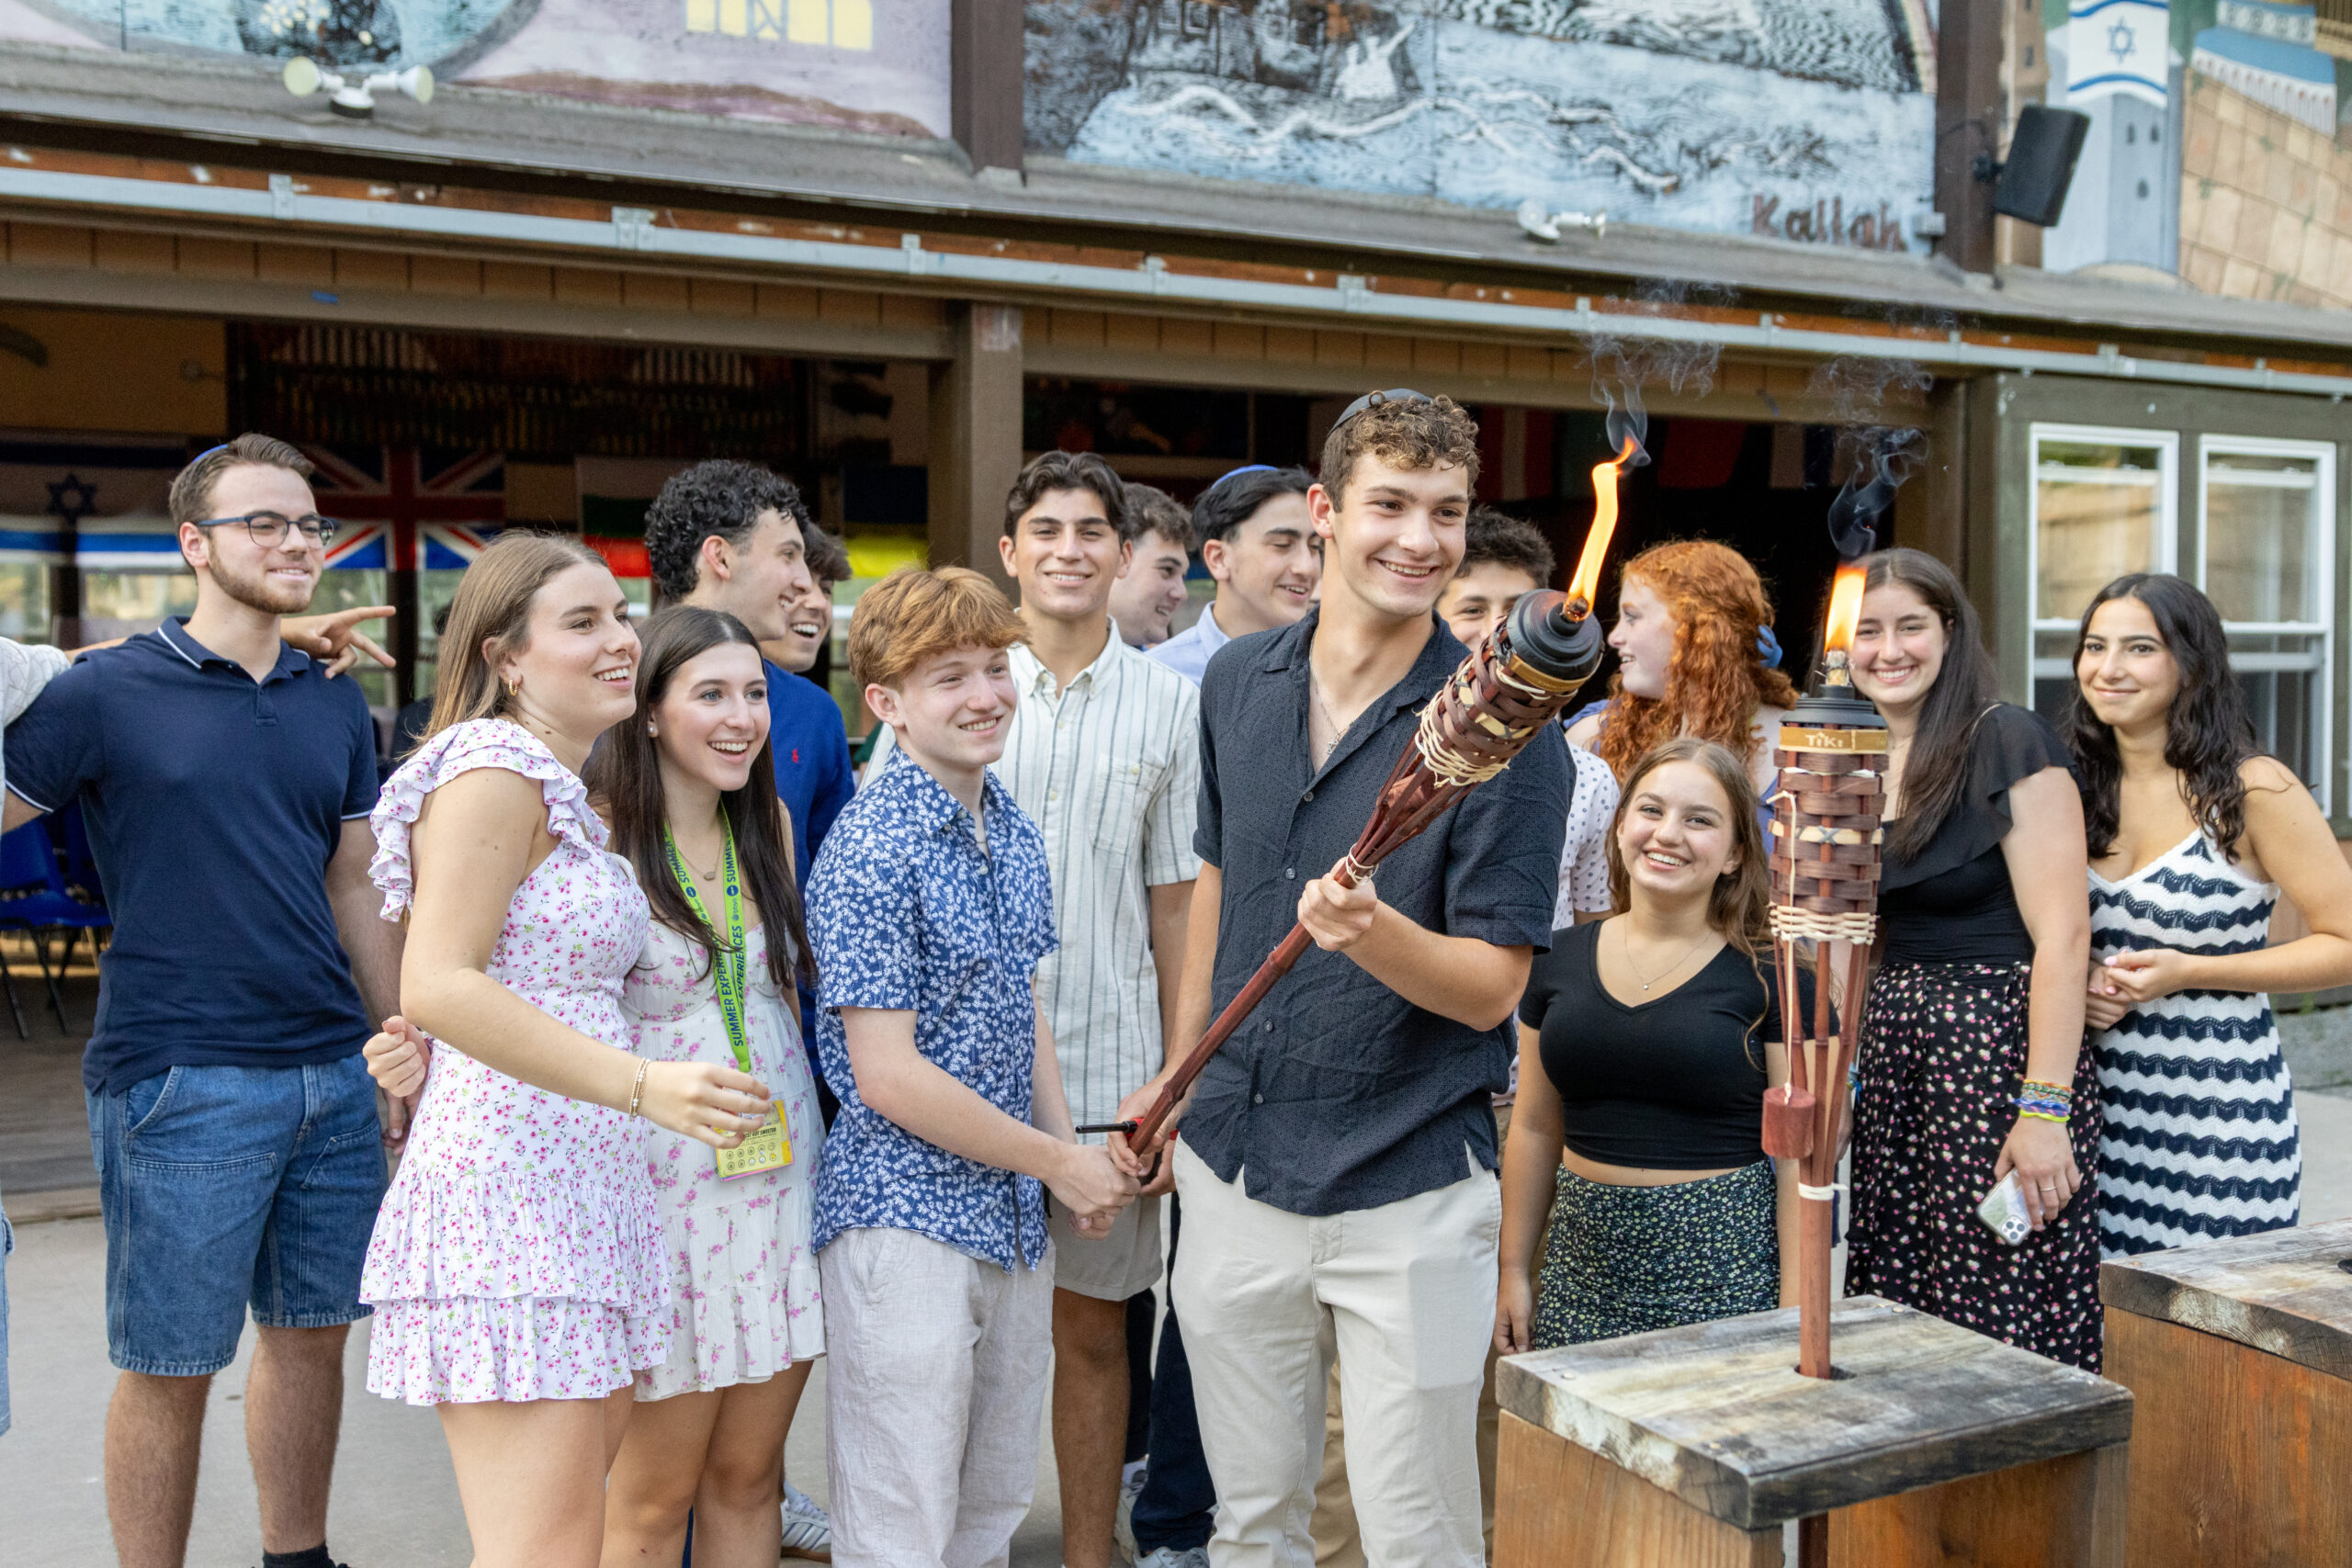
[{"xmin": 1496, "ymin": 1295, "xmax": 2131, "ymax": 1530}]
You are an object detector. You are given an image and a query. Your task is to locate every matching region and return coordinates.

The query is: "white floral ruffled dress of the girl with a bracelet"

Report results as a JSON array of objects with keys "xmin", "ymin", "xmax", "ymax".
[{"xmin": 360, "ymin": 719, "xmax": 671, "ymax": 1404}]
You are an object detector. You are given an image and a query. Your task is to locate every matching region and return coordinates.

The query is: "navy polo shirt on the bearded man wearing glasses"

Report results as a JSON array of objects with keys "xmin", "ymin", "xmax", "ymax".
[{"xmin": 5, "ymin": 621, "xmax": 377, "ymax": 1093}]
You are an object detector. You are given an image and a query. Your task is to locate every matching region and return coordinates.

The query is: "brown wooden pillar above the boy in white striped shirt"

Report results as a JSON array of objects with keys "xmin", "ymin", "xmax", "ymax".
[{"xmin": 929, "ymin": 301, "xmax": 1021, "ymax": 592}]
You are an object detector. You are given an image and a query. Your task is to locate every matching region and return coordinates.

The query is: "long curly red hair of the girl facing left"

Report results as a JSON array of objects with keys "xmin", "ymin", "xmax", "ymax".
[{"xmin": 1592, "ymin": 538, "xmax": 1797, "ymax": 778}]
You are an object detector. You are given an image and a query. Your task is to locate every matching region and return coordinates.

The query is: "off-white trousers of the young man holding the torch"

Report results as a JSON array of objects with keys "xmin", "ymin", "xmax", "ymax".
[{"xmin": 1173, "ymin": 1143, "xmax": 1503, "ymax": 1568}]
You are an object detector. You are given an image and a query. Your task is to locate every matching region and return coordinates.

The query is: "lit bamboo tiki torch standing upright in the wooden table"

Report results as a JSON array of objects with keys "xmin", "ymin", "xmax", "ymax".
[{"xmin": 1764, "ymin": 562, "xmax": 1886, "ymax": 1378}]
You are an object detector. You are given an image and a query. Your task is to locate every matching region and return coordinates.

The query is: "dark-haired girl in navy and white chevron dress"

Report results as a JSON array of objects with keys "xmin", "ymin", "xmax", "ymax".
[{"xmin": 2067, "ymin": 573, "xmax": 2352, "ymax": 1258}]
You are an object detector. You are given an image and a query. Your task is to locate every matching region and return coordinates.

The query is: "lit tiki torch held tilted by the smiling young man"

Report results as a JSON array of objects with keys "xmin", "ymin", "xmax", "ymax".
[{"xmin": 1129, "ymin": 434, "xmax": 1642, "ymax": 1147}]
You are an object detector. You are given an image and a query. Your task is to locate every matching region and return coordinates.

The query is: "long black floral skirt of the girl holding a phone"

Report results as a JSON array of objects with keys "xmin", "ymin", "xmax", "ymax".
[{"xmin": 1847, "ymin": 962, "xmax": 2100, "ymax": 1373}]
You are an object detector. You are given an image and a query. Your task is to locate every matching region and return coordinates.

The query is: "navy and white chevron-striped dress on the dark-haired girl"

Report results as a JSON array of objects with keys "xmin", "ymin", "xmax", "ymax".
[{"xmin": 2091, "ymin": 832, "xmax": 2302, "ymax": 1258}]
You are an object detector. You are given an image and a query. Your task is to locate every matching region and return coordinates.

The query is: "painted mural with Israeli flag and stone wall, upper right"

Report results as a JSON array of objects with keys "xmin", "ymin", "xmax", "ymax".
[{"xmin": 2020, "ymin": 0, "xmax": 2352, "ymax": 310}]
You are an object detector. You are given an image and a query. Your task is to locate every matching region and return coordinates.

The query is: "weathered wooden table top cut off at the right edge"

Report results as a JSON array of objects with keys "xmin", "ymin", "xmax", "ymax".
[{"xmin": 2098, "ymin": 1220, "xmax": 2352, "ymax": 1380}]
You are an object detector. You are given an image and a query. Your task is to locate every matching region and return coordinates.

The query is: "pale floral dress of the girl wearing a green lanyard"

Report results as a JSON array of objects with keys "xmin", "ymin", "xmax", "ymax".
[{"xmin": 621, "ymin": 924, "xmax": 826, "ymax": 1399}]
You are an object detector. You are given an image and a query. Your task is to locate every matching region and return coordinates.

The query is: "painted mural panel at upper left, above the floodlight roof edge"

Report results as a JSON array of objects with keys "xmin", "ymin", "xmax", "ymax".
[{"xmin": 0, "ymin": 0, "xmax": 948, "ymax": 136}]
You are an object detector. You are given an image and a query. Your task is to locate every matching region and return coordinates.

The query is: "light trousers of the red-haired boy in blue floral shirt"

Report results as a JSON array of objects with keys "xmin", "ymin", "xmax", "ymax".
[{"xmin": 816, "ymin": 1229, "xmax": 1054, "ymax": 1568}]
